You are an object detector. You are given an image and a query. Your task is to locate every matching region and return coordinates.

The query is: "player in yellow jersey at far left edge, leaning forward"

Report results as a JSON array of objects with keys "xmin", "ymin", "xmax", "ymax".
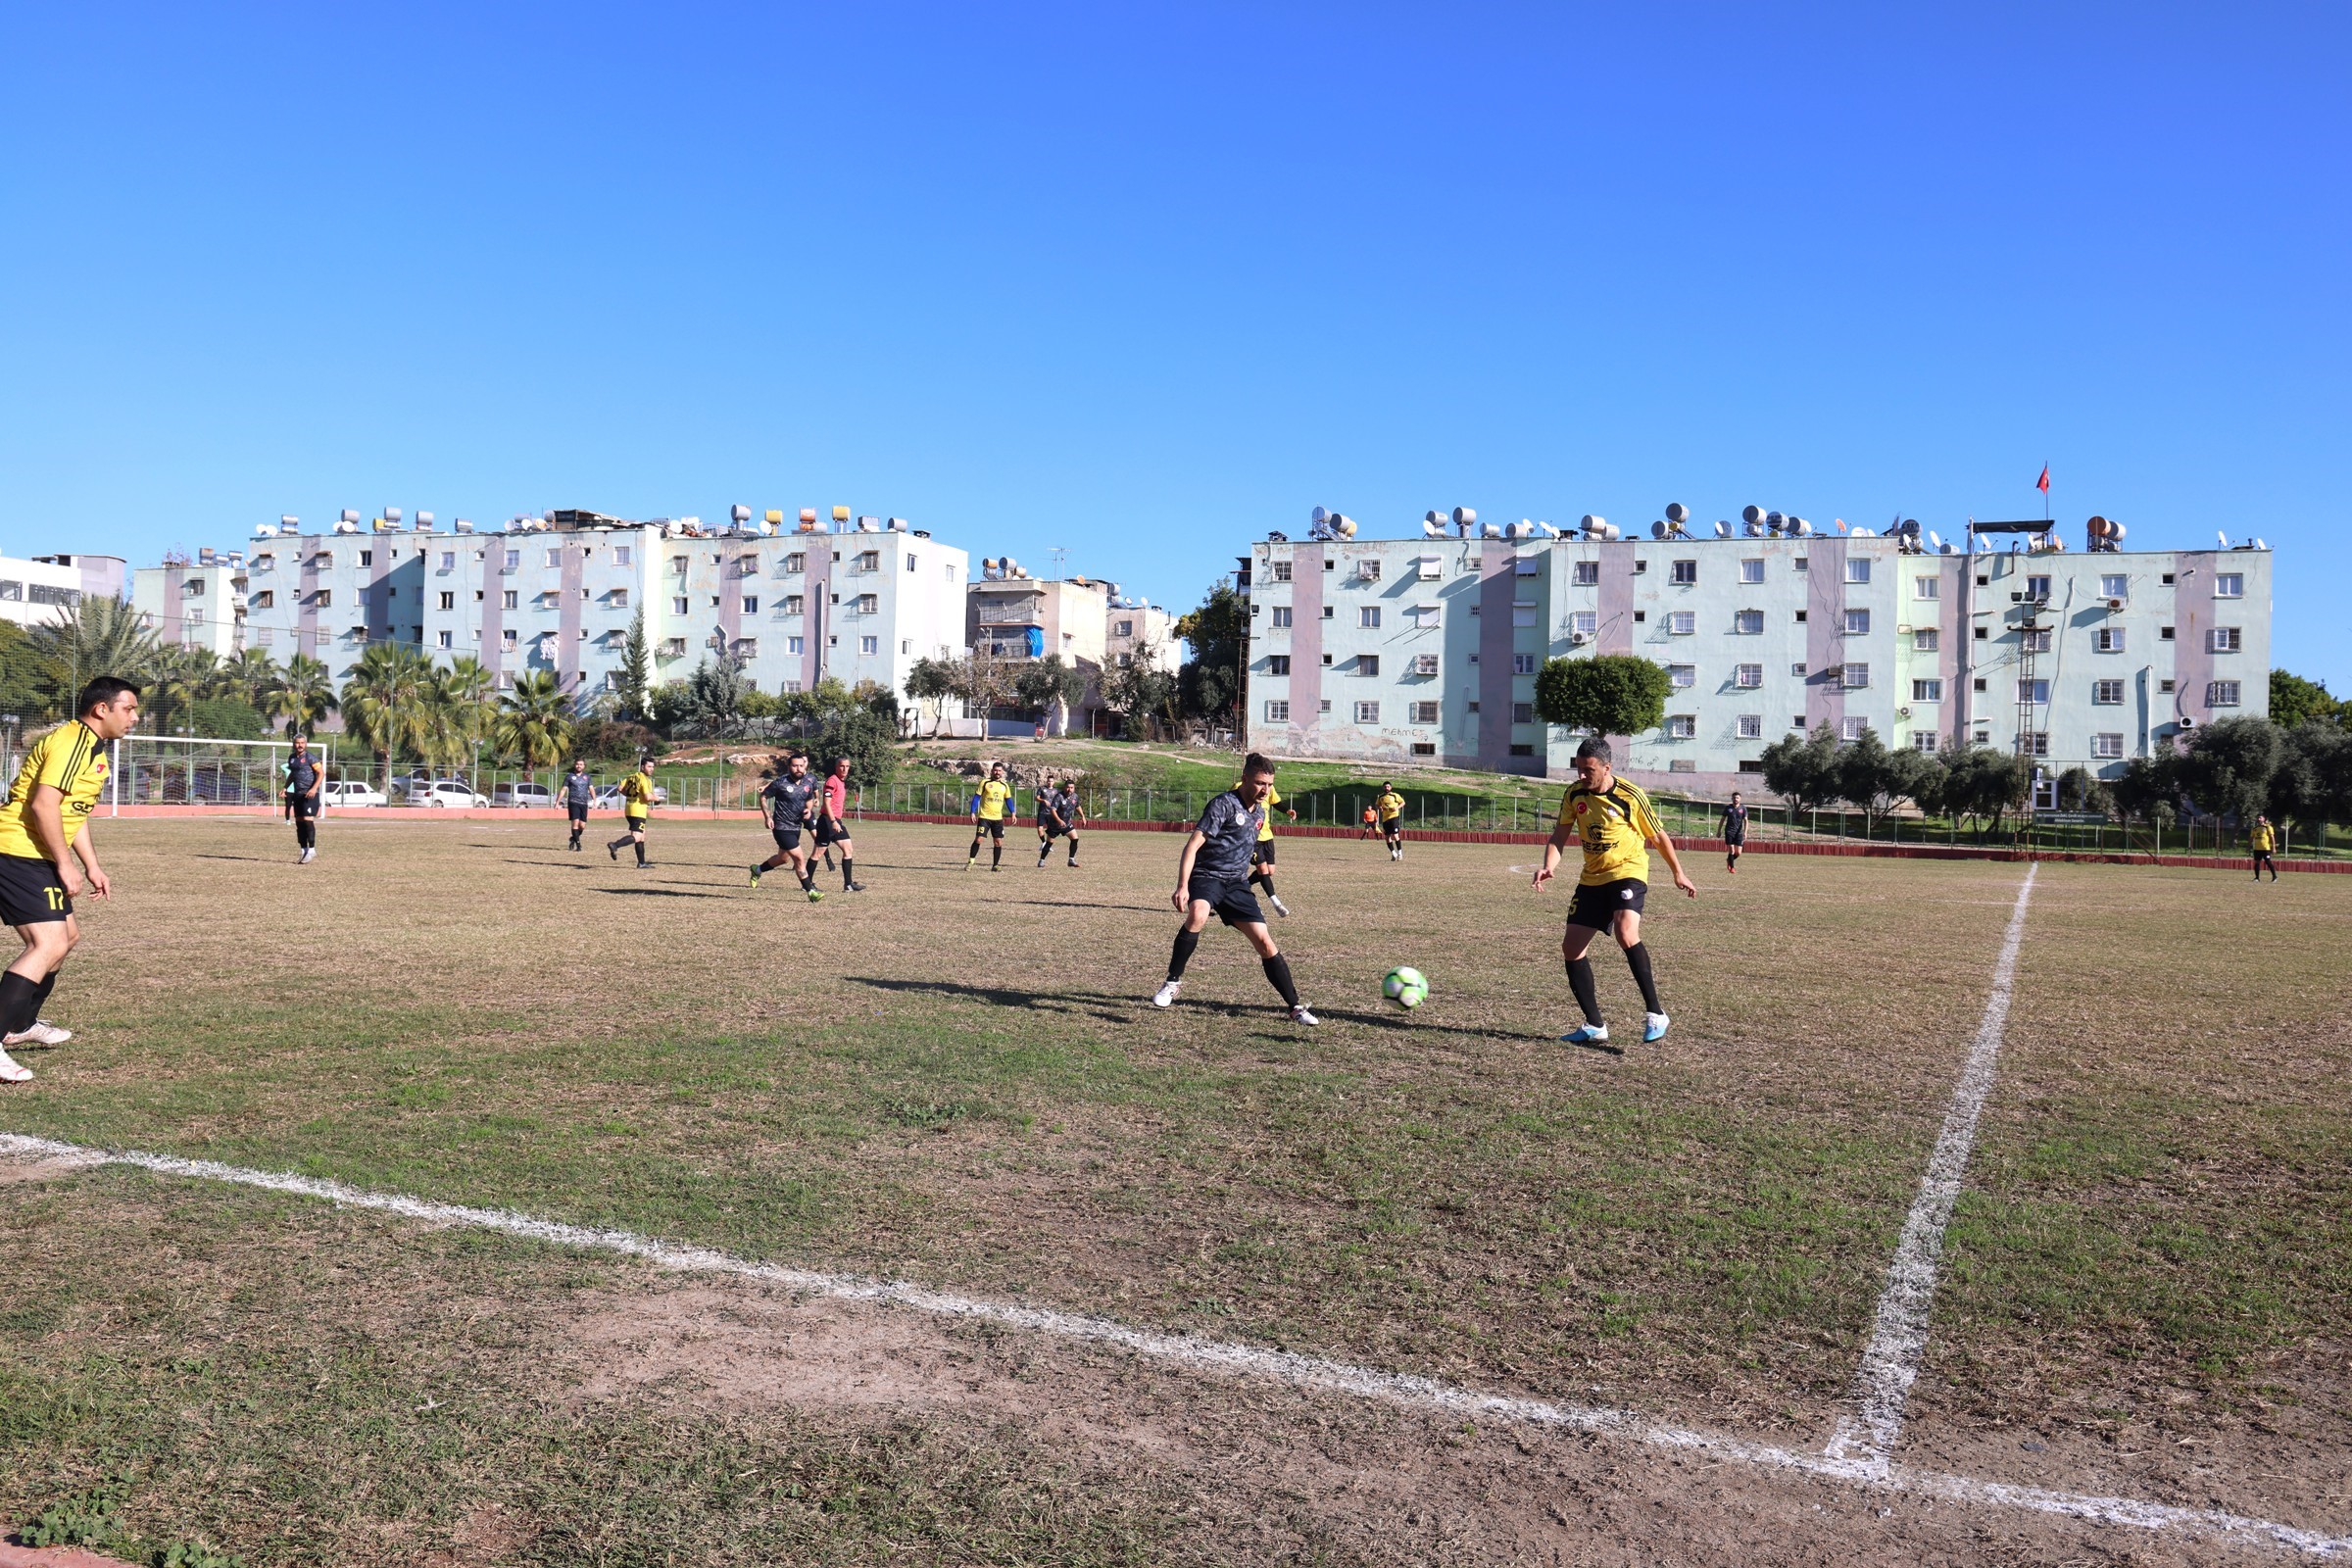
[{"xmin": 0, "ymin": 674, "xmax": 139, "ymax": 1084}]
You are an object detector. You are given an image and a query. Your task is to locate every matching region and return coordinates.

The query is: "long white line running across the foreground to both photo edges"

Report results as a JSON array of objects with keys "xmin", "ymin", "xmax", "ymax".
[{"xmin": 0, "ymin": 1133, "xmax": 2352, "ymax": 1556}]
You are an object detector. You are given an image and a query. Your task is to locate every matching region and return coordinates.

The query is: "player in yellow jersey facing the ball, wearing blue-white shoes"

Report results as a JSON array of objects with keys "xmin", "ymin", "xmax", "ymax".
[{"xmin": 1536, "ymin": 736, "xmax": 1698, "ymax": 1046}]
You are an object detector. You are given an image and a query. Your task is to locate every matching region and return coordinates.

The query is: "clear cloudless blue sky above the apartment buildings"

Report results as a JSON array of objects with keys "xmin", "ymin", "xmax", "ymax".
[{"xmin": 0, "ymin": 5, "xmax": 2352, "ymax": 691}]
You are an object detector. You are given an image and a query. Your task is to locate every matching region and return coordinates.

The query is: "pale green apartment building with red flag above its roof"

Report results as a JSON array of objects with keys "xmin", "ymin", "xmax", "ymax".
[{"xmin": 1245, "ymin": 534, "xmax": 2270, "ymax": 795}]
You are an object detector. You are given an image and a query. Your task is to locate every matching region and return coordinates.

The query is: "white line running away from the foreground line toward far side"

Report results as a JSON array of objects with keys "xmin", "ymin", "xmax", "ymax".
[{"xmin": 1828, "ymin": 862, "xmax": 2041, "ymax": 1469}]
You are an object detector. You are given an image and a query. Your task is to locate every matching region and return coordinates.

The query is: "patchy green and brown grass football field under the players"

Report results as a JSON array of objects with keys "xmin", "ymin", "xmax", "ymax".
[{"xmin": 0, "ymin": 813, "xmax": 2352, "ymax": 1566}]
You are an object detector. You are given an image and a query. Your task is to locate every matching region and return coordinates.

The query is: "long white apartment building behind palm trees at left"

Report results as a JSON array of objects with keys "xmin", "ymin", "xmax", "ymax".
[{"xmin": 131, "ymin": 511, "xmax": 969, "ymax": 710}]
